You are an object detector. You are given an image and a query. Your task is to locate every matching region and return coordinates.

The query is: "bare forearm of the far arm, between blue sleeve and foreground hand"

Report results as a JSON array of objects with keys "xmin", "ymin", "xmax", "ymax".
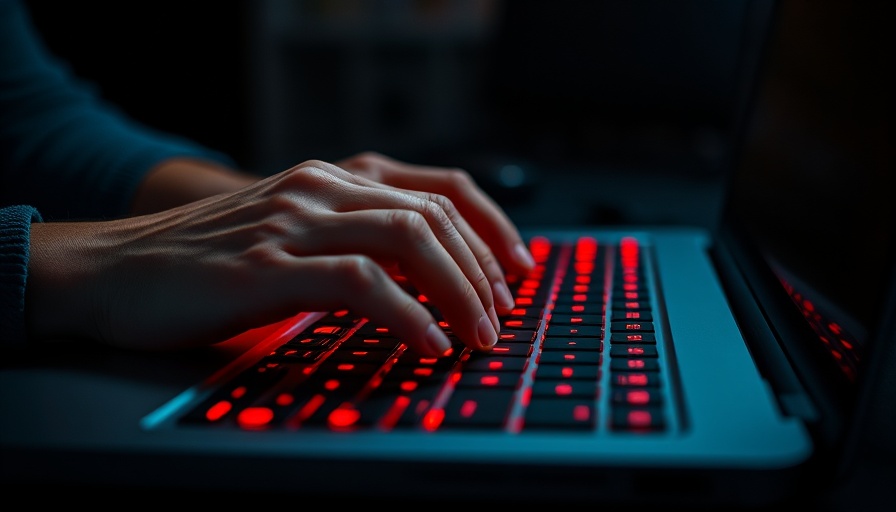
[{"xmin": 131, "ymin": 158, "xmax": 260, "ymax": 215}]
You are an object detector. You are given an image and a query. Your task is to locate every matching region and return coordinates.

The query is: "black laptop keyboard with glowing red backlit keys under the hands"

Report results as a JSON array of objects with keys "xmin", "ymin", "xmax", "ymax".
[{"xmin": 178, "ymin": 237, "xmax": 668, "ymax": 433}]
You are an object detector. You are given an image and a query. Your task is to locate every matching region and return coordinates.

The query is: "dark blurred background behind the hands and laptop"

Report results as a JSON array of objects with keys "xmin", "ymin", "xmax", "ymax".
[{"xmin": 27, "ymin": 0, "xmax": 756, "ymax": 225}]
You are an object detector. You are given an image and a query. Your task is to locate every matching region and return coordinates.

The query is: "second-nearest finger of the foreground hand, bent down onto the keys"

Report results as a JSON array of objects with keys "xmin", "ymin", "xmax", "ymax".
[{"xmin": 285, "ymin": 209, "xmax": 497, "ymax": 350}]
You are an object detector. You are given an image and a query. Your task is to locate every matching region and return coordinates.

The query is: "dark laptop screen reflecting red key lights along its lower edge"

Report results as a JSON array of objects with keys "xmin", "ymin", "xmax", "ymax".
[{"xmin": 728, "ymin": 0, "xmax": 896, "ymax": 380}]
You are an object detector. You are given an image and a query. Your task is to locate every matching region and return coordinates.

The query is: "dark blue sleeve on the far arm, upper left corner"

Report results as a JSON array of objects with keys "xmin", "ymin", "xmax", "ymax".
[{"xmin": 0, "ymin": 0, "xmax": 234, "ymax": 221}]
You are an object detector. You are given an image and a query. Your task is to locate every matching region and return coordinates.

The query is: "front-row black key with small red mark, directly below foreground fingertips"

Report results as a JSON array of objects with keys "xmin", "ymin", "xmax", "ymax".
[{"xmin": 442, "ymin": 389, "xmax": 514, "ymax": 427}]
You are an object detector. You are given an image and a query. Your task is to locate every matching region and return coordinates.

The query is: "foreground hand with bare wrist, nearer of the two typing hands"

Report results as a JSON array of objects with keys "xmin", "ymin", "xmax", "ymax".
[{"xmin": 26, "ymin": 161, "xmax": 532, "ymax": 356}]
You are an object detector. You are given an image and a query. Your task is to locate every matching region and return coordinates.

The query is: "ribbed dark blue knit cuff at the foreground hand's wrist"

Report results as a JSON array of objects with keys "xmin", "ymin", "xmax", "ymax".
[{"xmin": 0, "ymin": 206, "xmax": 42, "ymax": 347}]
